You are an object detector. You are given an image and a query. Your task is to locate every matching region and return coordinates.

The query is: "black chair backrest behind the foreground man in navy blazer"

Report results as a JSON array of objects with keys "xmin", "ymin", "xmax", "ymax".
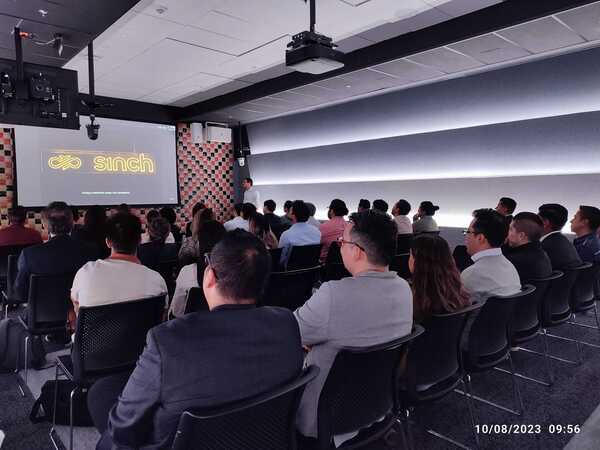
[{"xmin": 172, "ymin": 366, "xmax": 319, "ymax": 450}]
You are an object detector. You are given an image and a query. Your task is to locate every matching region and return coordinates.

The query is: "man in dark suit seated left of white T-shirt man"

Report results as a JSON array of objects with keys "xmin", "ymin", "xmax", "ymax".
[{"xmin": 15, "ymin": 202, "xmax": 100, "ymax": 300}]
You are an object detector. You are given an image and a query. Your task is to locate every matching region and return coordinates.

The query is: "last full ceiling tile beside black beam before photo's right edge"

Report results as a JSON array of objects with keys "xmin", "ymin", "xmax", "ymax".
[{"xmin": 498, "ymin": 17, "xmax": 585, "ymax": 53}]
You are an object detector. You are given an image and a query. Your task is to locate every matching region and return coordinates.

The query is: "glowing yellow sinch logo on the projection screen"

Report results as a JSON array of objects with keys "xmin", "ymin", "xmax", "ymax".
[{"xmin": 48, "ymin": 151, "xmax": 156, "ymax": 174}]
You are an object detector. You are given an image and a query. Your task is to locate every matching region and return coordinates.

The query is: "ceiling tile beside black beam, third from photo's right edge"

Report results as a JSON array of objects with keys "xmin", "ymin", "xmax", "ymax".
[{"xmin": 448, "ymin": 34, "xmax": 531, "ymax": 64}]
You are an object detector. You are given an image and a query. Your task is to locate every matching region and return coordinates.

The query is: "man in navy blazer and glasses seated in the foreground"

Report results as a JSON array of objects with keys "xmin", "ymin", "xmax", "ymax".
[{"xmin": 88, "ymin": 229, "xmax": 303, "ymax": 449}]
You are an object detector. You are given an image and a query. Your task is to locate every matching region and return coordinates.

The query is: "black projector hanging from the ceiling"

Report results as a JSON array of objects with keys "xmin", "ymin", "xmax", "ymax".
[{"xmin": 285, "ymin": 31, "xmax": 344, "ymax": 74}]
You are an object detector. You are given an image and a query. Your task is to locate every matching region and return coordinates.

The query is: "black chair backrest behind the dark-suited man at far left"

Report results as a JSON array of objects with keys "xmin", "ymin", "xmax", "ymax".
[{"xmin": 27, "ymin": 273, "xmax": 75, "ymax": 334}]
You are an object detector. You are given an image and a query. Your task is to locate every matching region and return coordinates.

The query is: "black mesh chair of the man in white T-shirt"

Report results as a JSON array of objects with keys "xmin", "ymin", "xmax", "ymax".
[{"xmin": 50, "ymin": 295, "xmax": 165, "ymax": 450}]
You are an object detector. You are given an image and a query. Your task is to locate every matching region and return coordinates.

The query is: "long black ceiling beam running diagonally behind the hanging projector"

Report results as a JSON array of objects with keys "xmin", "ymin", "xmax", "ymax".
[{"xmin": 179, "ymin": 0, "xmax": 597, "ymax": 121}]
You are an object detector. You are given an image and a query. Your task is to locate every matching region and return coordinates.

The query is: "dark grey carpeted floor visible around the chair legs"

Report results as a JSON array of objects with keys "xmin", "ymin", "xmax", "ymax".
[{"xmin": 0, "ymin": 310, "xmax": 600, "ymax": 450}]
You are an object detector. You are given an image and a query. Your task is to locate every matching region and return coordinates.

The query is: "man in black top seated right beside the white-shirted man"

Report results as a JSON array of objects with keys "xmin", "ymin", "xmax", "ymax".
[{"xmin": 502, "ymin": 212, "xmax": 552, "ymax": 284}]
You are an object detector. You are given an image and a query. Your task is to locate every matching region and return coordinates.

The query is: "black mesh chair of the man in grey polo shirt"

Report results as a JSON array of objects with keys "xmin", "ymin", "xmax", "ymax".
[{"xmin": 317, "ymin": 325, "xmax": 423, "ymax": 450}]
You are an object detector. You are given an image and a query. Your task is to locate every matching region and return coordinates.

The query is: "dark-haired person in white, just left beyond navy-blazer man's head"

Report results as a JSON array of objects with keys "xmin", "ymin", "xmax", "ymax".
[{"xmin": 169, "ymin": 220, "xmax": 227, "ymax": 317}]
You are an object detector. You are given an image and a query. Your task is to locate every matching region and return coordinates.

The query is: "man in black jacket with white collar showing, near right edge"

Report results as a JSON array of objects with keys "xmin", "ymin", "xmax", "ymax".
[{"xmin": 538, "ymin": 203, "xmax": 581, "ymax": 270}]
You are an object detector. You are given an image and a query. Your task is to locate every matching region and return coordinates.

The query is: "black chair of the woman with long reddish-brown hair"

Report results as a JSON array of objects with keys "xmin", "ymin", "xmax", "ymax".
[{"xmin": 396, "ymin": 303, "xmax": 482, "ymax": 448}]
